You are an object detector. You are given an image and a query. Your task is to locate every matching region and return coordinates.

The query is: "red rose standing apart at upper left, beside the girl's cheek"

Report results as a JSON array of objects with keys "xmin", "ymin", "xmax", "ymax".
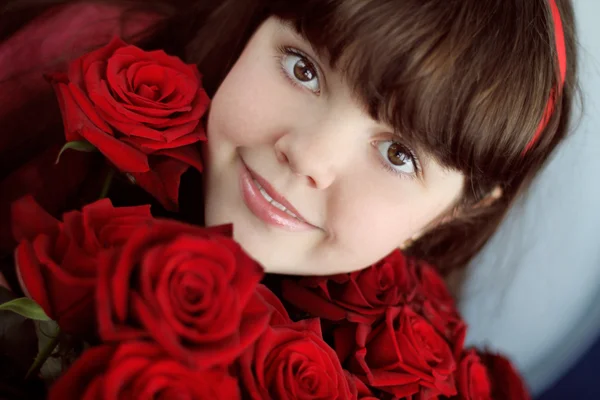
[{"xmin": 49, "ymin": 38, "xmax": 209, "ymax": 209}]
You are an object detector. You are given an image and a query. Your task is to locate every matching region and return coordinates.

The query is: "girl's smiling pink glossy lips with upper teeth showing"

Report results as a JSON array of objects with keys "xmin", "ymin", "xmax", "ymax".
[{"xmin": 240, "ymin": 161, "xmax": 316, "ymax": 232}]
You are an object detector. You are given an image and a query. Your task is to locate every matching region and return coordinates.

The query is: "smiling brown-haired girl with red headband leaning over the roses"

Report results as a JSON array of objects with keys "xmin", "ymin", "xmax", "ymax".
[{"xmin": 0, "ymin": 0, "xmax": 577, "ymax": 275}]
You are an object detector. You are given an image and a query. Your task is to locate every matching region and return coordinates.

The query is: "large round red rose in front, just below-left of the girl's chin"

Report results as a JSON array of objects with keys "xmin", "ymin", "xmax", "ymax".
[{"xmin": 96, "ymin": 220, "xmax": 270, "ymax": 368}]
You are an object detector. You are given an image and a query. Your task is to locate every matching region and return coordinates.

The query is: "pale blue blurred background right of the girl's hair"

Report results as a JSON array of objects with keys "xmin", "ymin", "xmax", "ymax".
[{"xmin": 459, "ymin": 0, "xmax": 600, "ymax": 400}]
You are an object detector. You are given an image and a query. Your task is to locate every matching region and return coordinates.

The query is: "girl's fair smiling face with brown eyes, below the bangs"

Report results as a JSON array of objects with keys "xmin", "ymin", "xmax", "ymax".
[{"xmin": 205, "ymin": 18, "xmax": 464, "ymax": 275}]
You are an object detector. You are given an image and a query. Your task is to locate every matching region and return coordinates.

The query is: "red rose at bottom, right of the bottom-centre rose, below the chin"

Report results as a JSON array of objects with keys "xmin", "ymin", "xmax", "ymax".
[{"xmin": 344, "ymin": 306, "xmax": 456, "ymax": 398}]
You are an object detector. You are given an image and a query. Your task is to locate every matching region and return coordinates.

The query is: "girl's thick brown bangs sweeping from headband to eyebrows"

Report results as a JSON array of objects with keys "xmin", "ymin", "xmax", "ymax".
[{"xmin": 275, "ymin": 0, "xmax": 555, "ymax": 188}]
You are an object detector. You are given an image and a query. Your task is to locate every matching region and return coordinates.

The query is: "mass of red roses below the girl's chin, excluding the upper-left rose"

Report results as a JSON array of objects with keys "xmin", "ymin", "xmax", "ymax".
[{"xmin": 4, "ymin": 198, "xmax": 526, "ymax": 400}]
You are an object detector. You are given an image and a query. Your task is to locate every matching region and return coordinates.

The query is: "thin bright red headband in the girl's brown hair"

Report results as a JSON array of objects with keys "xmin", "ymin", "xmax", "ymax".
[{"xmin": 523, "ymin": 0, "xmax": 567, "ymax": 154}]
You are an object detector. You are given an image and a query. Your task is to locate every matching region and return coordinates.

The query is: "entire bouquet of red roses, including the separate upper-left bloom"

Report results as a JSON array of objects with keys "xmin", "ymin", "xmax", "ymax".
[{"xmin": 0, "ymin": 40, "xmax": 529, "ymax": 400}]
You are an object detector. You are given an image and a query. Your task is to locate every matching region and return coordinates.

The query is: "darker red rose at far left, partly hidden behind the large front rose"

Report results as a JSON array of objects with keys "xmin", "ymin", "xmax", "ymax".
[{"xmin": 12, "ymin": 197, "xmax": 152, "ymax": 334}]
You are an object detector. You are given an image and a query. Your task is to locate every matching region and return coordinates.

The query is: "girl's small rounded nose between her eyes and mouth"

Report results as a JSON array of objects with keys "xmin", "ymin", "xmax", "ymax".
[{"xmin": 274, "ymin": 118, "xmax": 359, "ymax": 189}]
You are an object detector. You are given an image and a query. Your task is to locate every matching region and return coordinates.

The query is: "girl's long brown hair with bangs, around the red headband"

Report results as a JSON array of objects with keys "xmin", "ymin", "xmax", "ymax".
[{"xmin": 0, "ymin": 0, "xmax": 577, "ymax": 270}]
